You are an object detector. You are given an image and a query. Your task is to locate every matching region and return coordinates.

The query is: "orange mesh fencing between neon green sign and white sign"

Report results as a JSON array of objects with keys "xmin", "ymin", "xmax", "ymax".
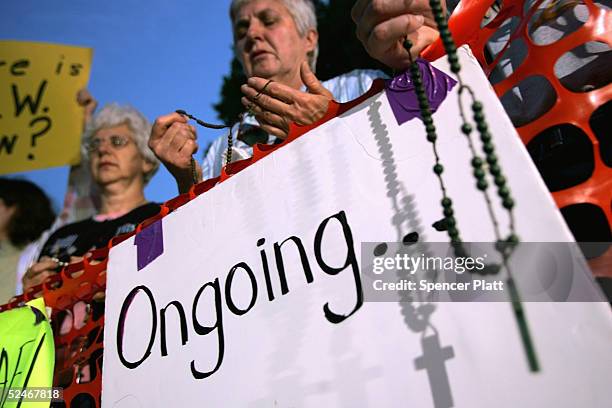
[{"xmin": 0, "ymin": 248, "xmax": 108, "ymax": 407}]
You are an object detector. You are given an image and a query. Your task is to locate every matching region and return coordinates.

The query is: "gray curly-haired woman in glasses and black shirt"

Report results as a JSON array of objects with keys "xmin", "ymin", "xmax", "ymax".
[{"xmin": 23, "ymin": 104, "xmax": 159, "ymax": 290}]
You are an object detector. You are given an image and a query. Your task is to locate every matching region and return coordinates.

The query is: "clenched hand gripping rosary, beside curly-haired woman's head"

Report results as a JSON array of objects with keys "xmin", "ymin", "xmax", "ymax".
[{"xmin": 149, "ymin": 112, "xmax": 202, "ymax": 193}]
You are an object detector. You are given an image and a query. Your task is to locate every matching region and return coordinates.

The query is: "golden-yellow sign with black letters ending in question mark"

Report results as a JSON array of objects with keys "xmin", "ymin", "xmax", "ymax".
[{"xmin": 0, "ymin": 41, "xmax": 92, "ymax": 174}]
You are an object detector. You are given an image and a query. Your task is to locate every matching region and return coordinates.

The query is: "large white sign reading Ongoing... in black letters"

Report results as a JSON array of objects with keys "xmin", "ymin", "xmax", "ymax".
[{"xmin": 102, "ymin": 50, "xmax": 612, "ymax": 408}]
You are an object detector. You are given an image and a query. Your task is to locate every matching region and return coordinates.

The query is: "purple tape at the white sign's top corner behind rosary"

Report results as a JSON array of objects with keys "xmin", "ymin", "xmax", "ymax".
[{"xmin": 385, "ymin": 58, "xmax": 457, "ymax": 125}]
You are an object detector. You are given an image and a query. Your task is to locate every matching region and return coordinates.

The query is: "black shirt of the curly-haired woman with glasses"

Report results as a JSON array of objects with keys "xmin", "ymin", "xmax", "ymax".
[{"xmin": 39, "ymin": 203, "xmax": 160, "ymax": 262}]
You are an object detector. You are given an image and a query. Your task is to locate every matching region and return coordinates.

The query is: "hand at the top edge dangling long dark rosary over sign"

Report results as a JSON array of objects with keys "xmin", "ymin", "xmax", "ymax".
[{"xmin": 351, "ymin": 0, "xmax": 446, "ymax": 70}]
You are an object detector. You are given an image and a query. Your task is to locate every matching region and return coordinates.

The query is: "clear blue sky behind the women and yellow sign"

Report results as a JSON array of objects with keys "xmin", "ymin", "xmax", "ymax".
[{"xmin": 0, "ymin": 0, "xmax": 237, "ymax": 214}]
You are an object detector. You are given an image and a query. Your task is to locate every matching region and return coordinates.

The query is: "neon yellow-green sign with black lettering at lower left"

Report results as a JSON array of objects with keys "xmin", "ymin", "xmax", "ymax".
[{"xmin": 0, "ymin": 298, "xmax": 59, "ymax": 408}]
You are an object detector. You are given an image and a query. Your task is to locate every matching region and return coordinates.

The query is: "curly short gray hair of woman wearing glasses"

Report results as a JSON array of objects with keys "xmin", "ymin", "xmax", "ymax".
[{"xmin": 81, "ymin": 103, "xmax": 159, "ymax": 184}]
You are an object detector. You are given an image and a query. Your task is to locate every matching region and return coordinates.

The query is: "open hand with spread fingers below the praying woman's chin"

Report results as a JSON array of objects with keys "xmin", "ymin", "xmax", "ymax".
[{"xmin": 240, "ymin": 62, "xmax": 333, "ymax": 139}]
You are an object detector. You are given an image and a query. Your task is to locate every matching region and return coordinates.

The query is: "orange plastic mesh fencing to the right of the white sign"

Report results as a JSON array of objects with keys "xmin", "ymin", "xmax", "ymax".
[{"xmin": 427, "ymin": 0, "xmax": 612, "ymax": 277}]
